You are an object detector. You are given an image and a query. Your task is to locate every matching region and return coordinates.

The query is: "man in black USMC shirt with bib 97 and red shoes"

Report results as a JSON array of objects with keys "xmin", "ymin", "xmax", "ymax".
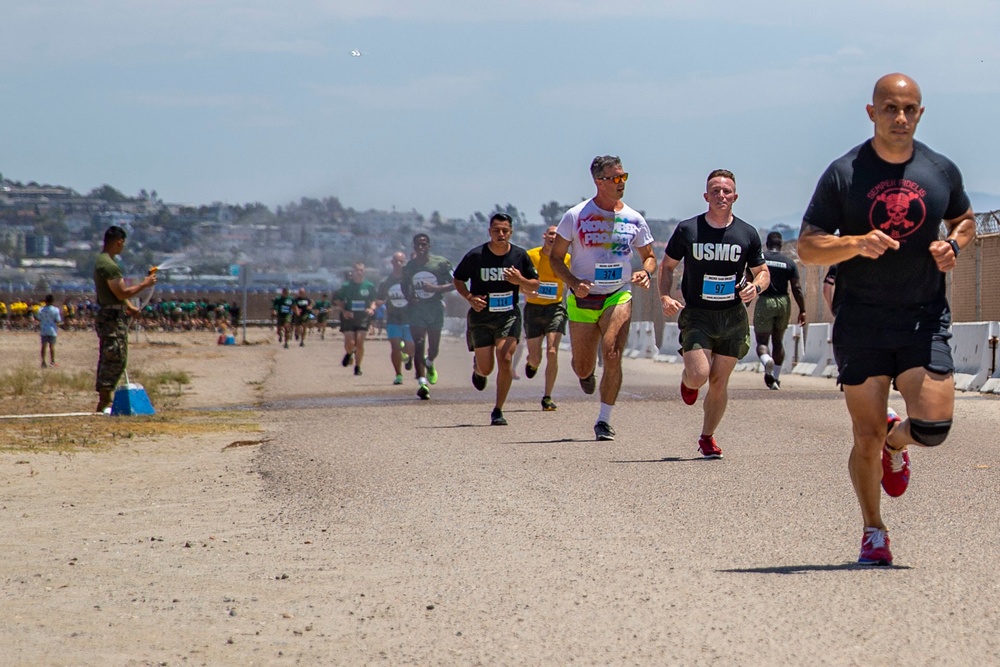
[{"xmin": 660, "ymin": 169, "xmax": 769, "ymax": 459}]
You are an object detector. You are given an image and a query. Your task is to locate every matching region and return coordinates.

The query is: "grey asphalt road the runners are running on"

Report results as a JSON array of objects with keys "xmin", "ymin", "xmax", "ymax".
[{"xmin": 254, "ymin": 339, "xmax": 1000, "ymax": 666}]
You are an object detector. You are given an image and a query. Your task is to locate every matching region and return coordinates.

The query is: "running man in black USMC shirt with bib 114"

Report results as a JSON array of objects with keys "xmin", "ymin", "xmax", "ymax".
[{"xmin": 453, "ymin": 213, "xmax": 539, "ymax": 426}]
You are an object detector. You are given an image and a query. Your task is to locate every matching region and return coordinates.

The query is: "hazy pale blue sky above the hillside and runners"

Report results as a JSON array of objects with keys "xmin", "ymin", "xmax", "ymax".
[{"xmin": 0, "ymin": 0, "xmax": 1000, "ymax": 224}]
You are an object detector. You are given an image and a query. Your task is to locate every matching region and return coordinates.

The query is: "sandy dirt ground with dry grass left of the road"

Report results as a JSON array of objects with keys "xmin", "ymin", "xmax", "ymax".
[{"xmin": 0, "ymin": 331, "xmax": 292, "ymax": 665}]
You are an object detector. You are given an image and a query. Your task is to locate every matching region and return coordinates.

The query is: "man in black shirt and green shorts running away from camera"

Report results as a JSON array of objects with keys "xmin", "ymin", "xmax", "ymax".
[{"xmin": 753, "ymin": 232, "xmax": 806, "ymax": 389}]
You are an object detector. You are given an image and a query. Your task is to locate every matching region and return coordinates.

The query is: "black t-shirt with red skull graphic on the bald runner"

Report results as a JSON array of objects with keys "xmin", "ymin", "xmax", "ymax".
[{"xmin": 802, "ymin": 140, "xmax": 970, "ymax": 310}]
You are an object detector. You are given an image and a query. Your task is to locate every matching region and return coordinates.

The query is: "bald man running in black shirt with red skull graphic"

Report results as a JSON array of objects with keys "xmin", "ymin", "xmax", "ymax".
[{"xmin": 798, "ymin": 73, "xmax": 976, "ymax": 565}]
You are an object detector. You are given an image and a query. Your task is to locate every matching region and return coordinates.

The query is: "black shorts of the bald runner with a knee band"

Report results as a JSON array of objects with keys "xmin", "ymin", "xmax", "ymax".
[{"xmin": 833, "ymin": 301, "xmax": 955, "ymax": 386}]
